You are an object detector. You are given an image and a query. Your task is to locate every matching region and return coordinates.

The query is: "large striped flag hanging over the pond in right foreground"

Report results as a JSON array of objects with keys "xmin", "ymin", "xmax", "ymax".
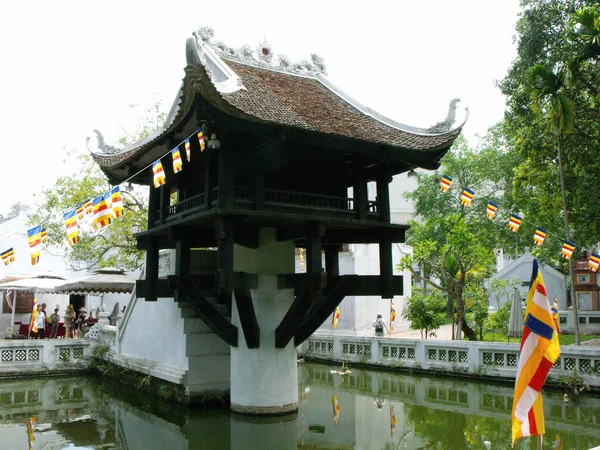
[{"xmin": 512, "ymin": 259, "xmax": 560, "ymax": 447}]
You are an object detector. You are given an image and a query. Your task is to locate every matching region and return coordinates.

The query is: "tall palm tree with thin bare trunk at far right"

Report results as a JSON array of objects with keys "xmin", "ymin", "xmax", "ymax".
[{"xmin": 527, "ymin": 64, "xmax": 580, "ymax": 345}]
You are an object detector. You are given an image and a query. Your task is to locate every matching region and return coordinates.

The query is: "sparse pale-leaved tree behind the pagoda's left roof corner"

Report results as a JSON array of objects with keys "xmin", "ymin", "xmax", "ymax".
[{"xmin": 29, "ymin": 102, "xmax": 166, "ymax": 270}]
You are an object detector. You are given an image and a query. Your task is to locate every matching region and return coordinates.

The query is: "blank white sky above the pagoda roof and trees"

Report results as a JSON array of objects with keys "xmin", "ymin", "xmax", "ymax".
[{"xmin": 0, "ymin": 0, "xmax": 519, "ymax": 213}]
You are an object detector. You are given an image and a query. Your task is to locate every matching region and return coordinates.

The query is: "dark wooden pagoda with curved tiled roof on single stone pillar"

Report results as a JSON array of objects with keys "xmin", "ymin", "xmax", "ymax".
[{"xmin": 94, "ymin": 29, "xmax": 464, "ymax": 413}]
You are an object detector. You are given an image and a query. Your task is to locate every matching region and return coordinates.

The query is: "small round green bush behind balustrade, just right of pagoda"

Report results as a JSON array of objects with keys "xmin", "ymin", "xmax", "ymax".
[{"xmin": 402, "ymin": 289, "xmax": 446, "ymax": 339}]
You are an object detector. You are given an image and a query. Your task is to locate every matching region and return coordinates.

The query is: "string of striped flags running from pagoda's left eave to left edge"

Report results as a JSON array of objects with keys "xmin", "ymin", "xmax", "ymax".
[{"xmin": 0, "ymin": 126, "xmax": 211, "ymax": 266}]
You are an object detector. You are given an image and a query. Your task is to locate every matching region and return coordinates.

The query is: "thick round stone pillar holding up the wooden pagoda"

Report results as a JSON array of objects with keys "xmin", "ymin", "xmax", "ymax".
[{"xmin": 231, "ymin": 228, "xmax": 298, "ymax": 415}]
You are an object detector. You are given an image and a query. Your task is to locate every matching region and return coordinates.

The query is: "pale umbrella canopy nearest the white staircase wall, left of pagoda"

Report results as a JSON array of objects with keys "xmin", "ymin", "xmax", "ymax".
[{"xmin": 54, "ymin": 267, "xmax": 135, "ymax": 295}]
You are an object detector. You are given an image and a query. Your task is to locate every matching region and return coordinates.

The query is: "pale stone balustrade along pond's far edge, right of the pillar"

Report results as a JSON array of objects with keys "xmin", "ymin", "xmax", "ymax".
[{"xmin": 298, "ymin": 334, "xmax": 600, "ymax": 388}]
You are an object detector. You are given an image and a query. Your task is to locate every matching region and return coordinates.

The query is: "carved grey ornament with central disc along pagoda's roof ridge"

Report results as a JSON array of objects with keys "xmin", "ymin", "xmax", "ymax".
[{"xmin": 192, "ymin": 26, "xmax": 327, "ymax": 76}]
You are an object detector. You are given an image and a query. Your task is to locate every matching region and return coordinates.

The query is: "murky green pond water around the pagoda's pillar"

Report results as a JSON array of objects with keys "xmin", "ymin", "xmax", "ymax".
[{"xmin": 0, "ymin": 363, "xmax": 600, "ymax": 450}]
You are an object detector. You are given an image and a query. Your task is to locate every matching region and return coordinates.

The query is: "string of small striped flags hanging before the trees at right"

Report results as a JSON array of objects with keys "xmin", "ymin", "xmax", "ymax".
[{"xmin": 440, "ymin": 175, "xmax": 600, "ymax": 272}]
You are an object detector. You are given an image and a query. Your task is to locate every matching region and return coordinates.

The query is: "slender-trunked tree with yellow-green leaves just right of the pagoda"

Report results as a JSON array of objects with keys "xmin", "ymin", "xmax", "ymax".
[{"xmin": 399, "ymin": 137, "xmax": 525, "ymax": 340}]
